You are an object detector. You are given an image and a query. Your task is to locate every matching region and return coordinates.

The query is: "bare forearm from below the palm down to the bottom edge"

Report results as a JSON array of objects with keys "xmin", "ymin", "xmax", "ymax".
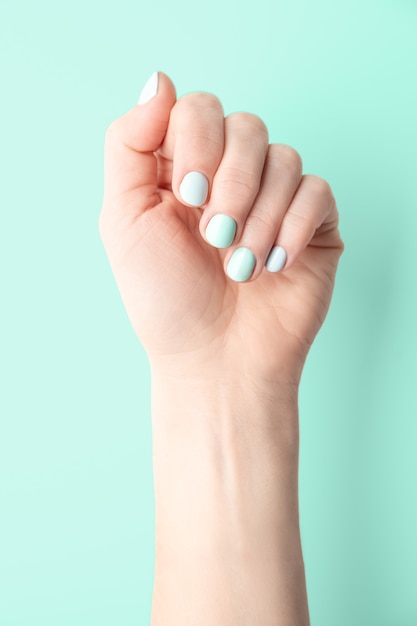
[{"xmin": 152, "ymin": 372, "xmax": 309, "ymax": 626}]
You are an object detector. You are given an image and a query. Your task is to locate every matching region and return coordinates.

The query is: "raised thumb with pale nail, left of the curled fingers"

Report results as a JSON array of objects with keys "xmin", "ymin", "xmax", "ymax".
[{"xmin": 102, "ymin": 72, "xmax": 176, "ymax": 218}]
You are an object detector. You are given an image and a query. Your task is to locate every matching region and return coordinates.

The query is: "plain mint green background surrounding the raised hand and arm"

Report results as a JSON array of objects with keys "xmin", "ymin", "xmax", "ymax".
[{"xmin": 0, "ymin": 0, "xmax": 417, "ymax": 626}]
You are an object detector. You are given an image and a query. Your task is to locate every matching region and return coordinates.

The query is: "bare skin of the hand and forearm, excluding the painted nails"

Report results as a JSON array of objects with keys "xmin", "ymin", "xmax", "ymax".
[{"xmin": 100, "ymin": 73, "xmax": 343, "ymax": 626}]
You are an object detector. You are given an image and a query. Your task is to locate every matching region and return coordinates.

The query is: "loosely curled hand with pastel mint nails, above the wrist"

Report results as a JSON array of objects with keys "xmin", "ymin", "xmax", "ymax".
[{"xmin": 100, "ymin": 73, "xmax": 343, "ymax": 384}]
